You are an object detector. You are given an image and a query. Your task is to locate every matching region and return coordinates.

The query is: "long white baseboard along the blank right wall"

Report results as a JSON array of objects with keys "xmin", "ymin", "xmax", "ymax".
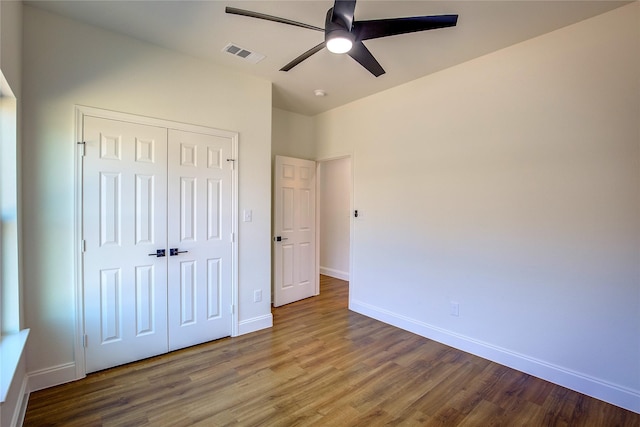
[{"xmin": 349, "ymin": 300, "xmax": 640, "ymax": 413}]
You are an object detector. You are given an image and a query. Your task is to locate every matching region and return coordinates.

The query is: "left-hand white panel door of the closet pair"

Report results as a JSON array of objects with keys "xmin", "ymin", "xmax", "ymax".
[{"xmin": 83, "ymin": 117, "xmax": 168, "ymax": 372}]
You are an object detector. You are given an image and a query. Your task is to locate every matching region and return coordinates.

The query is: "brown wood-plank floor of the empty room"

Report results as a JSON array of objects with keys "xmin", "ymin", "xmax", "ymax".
[{"xmin": 24, "ymin": 276, "xmax": 640, "ymax": 427}]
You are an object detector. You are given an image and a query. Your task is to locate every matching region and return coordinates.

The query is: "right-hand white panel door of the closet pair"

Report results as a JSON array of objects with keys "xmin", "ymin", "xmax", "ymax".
[{"xmin": 168, "ymin": 130, "xmax": 234, "ymax": 350}]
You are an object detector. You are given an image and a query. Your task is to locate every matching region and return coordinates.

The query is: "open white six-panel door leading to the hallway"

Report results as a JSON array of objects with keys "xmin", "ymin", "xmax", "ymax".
[{"xmin": 273, "ymin": 156, "xmax": 318, "ymax": 307}]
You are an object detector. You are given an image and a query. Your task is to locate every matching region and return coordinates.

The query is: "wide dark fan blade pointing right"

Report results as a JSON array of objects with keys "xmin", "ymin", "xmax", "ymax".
[{"xmin": 353, "ymin": 15, "xmax": 458, "ymax": 40}]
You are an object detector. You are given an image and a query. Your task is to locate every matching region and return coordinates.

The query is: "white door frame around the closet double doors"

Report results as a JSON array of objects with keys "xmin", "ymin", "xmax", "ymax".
[{"xmin": 73, "ymin": 105, "xmax": 239, "ymax": 379}]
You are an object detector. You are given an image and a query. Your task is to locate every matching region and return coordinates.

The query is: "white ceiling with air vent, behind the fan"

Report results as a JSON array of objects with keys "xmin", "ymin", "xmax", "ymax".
[{"xmin": 26, "ymin": 0, "xmax": 629, "ymax": 115}]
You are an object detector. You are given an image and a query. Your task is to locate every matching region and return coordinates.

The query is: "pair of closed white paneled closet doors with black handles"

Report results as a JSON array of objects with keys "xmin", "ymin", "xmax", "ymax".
[{"xmin": 82, "ymin": 116, "xmax": 235, "ymax": 373}]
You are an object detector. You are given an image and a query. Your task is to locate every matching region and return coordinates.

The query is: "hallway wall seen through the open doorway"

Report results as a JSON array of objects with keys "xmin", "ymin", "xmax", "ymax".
[{"xmin": 318, "ymin": 157, "xmax": 351, "ymax": 280}]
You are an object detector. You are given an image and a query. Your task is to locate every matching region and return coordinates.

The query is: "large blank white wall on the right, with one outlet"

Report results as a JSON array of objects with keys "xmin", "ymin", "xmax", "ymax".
[{"xmin": 316, "ymin": 2, "xmax": 640, "ymax": 412}]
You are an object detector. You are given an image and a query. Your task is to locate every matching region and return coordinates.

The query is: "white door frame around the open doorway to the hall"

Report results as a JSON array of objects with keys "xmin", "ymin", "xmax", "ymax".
[{"xmin": 316, "ymin": 153, "xmax": 355, "ymax": 308}]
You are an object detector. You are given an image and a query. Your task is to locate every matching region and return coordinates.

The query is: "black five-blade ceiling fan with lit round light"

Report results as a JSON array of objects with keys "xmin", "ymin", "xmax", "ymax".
[{"xmin": 225, "ymin": 0, "xmax": 458, "ymax": 77}]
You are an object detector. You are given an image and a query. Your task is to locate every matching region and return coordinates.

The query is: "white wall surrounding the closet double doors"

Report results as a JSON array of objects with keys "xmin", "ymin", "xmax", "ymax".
[{"xmin": 22, "ymin": 6, "xmax": 271, "ymax": 388}]
